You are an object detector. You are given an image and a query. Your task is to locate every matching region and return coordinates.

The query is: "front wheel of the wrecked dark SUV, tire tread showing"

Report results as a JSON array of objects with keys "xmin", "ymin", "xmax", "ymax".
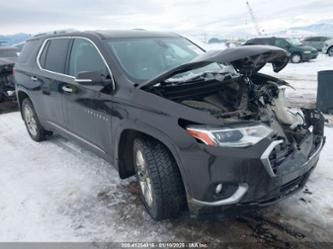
[{"xmin": 133, "ymin": 138, "xmax": 186, "ymax": 221}]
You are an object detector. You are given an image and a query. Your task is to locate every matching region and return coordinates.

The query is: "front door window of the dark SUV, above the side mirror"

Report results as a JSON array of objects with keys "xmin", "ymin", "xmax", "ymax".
[{"xmin": 68, "ymin": 39, "xmax": 108, "ymax": 77}]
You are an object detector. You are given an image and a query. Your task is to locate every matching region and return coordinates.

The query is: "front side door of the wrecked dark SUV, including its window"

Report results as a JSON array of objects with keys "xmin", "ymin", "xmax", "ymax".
[{"xmin": 63, "ymin": 38, "xmax": 111, "ymax": 154}]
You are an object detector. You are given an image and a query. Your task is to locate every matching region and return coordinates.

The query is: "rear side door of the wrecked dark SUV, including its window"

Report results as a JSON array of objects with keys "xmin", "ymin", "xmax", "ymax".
[{"xmin": 36, "ymin": 38, "xmax": 73, "ymax": 129}]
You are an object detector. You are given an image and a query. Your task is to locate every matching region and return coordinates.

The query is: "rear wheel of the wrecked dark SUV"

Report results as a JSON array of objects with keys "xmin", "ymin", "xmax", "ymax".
[{"xmin": 21, "ymin": 98, "xmax": 51, "ymax": 142}]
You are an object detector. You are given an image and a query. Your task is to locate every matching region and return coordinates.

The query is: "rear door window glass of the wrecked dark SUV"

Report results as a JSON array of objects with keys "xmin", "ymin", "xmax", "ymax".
[{"xmin": 40, "ymin": 38, "xmax": 70, "ymax": 73}]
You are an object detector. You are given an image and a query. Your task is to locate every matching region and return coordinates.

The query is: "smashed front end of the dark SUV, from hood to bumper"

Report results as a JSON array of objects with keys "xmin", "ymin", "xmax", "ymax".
[{"xmin": 141, "ymin": 46, "xmax": 325, "ymax": 215}]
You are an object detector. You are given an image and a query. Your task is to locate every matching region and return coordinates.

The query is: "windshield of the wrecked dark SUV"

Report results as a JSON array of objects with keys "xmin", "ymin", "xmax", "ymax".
[{"xmin": 107, "ymin": 37, "xmax": 221, "ymax": 83}]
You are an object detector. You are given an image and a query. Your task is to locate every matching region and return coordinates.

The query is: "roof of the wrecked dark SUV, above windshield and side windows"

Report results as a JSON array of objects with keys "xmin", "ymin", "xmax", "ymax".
[{"xmin": 31, "ymin": 29, "xmax": 179, "ymax": 40}]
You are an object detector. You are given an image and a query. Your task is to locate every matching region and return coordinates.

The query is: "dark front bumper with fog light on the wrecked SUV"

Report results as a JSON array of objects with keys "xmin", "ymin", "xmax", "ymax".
[{"xmin": 182, "ymin": 110, "xmax": 325, "ymax": 217}]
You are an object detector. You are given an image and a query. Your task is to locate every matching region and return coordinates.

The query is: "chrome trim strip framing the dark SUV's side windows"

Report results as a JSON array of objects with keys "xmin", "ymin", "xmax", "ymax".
[{"xmin": 36, "ymin": 36, "xmax": 116, "ymax": 90}]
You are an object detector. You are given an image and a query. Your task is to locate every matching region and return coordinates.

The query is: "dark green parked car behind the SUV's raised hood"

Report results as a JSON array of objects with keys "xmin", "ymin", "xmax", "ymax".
[{"xmin": 244, "ymin": 37, "xmax": 318, "ymax": 63}]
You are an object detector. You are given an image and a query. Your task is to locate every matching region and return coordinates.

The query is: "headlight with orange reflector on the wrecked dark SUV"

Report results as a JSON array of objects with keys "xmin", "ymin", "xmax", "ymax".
[{"xmin": 186, "ymin": 125, "xmax": 273, "ymax": 147}]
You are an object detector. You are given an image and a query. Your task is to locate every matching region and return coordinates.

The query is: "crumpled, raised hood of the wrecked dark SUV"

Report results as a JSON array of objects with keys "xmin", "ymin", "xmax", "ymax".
[{"xmin": 139, "ymin": 45, "xmax": 289, "ymax": 88}]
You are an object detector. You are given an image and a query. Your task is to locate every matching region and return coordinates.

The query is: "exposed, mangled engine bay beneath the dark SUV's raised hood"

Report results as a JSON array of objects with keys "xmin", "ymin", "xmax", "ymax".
[{"xmin": 149, "ymin": 70, "xmax": 324, "ymax": 154}]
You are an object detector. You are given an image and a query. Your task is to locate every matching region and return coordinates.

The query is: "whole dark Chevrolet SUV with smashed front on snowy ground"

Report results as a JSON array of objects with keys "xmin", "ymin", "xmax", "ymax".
[{"xmin": 15, "ymin": 30, "xmax": 325, "ymax": 220}]
